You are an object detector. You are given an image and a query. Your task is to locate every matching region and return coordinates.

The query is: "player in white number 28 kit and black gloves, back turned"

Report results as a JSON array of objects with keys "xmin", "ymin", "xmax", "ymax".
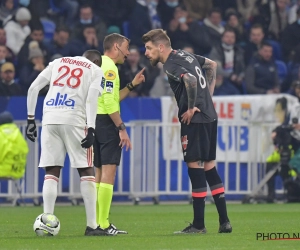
[{"xmin": 26, "ymin": 50, "xmax": 110, "ymax": 236}]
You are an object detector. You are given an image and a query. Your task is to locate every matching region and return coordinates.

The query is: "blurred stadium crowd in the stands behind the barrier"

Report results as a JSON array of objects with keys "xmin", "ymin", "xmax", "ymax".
[{"xmin": 0, "ymin": 0, "xmax": 300, "ymax": 97}]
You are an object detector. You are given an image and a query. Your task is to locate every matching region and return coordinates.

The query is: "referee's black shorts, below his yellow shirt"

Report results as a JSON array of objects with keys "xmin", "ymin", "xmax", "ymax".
[{"xmin": 94, "ymin": 115, "xmax": 122, "ymax": 168}]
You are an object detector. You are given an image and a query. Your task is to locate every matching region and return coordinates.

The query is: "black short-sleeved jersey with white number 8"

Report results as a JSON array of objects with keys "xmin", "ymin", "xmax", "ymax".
[{"xmin": 164, "ymin": 50, "xmax": 217, "ymax": 123}]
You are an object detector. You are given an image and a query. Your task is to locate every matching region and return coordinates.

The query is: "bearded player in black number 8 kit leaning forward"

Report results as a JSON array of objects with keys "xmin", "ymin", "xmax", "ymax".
[{"xmin": 142, "ymin": 29, "xmax": 232, "ymax": 234}]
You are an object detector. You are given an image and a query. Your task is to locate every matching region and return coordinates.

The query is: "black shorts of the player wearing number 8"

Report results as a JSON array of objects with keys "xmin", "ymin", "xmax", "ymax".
[{"xmin": 181, "ymin": 120, "xmax": 218, "ymax": 162}]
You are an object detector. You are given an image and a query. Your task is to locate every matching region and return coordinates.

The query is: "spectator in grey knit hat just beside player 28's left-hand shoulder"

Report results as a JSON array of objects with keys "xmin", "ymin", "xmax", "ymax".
[{"xmin": 20, "ymin": 41, "xmax": 45, "ymax": 93}]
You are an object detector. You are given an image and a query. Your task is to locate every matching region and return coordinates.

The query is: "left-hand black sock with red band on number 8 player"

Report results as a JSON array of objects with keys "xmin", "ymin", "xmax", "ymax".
[{"xmin": 188, "ymin": 168, "xmax": 207, "ymax": 229}]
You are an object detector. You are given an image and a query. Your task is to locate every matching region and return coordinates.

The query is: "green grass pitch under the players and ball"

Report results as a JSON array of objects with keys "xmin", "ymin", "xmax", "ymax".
[{"xmin": 0, "ymin": 204, "xmax": 300, "ymax": 250}]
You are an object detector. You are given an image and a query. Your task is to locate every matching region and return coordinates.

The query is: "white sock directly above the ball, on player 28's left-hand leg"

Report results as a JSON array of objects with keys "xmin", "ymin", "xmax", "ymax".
[{"xmin": 43, "ymin": 174, "xmax": 58, "ymax": 214}]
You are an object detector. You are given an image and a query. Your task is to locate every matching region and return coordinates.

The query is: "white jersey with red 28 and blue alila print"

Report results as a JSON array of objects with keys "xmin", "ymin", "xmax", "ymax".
[{"xmin": 40, "ymin": 56, "xmax": 104, "ymax": 127}]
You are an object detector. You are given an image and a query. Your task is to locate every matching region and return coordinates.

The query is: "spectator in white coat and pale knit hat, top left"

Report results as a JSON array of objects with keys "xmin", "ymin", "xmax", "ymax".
[{"xmin": 4, "ymin": 7, "xmax": 31, "ymax": 55}]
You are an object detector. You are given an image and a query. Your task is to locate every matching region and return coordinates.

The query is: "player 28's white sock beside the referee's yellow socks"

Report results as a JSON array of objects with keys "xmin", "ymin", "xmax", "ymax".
[{"xmin": 80, "ymin": 176, "xmax": 97, "ymax": 229}]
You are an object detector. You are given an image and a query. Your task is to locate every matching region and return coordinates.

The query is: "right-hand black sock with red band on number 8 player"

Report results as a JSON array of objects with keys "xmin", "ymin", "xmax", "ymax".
[{"xmin": 205, "ymin": 167, "xmax": 229, "ymax": 224}]
